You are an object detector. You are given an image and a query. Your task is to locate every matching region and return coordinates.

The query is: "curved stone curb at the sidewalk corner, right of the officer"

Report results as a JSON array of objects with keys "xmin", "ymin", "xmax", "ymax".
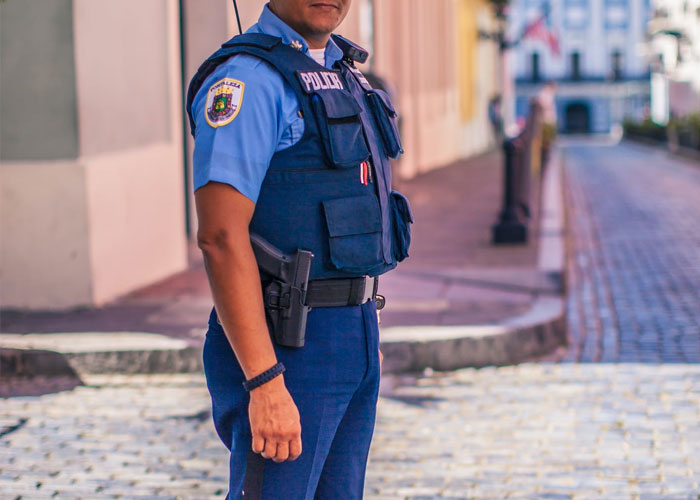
[{"xmin": 381, "ymin": 149, "xmax": 567, "ymax": 373}]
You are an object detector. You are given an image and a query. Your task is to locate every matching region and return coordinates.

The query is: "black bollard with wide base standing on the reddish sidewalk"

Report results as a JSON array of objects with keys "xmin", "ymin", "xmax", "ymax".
[{"xmin": 491, "ymin": 139, "xmax": 527, "ymax": 245}]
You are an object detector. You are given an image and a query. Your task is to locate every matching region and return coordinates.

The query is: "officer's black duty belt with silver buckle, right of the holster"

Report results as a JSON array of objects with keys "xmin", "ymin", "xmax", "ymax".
[{"xmin": 306, "ymin": 276, "xmax": 385, "ymax": 309}]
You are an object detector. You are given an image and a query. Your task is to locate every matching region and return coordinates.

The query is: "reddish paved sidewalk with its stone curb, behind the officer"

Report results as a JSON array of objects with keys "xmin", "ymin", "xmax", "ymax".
[{"xmin": 0, "ymin": 148, "xmax": 563, "ymax": 375}]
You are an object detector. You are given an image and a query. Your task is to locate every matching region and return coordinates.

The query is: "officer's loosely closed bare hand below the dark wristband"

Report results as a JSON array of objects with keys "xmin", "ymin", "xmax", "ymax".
[{"xmin": 248, "ymin": 376, "xmax": 301, "ymax": 462}]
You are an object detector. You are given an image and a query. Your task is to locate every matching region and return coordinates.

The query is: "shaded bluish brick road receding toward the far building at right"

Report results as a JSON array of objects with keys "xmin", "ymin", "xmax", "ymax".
[{"xmin": 566, "ymin": 139, "xmax": 700, "ymax": 363}]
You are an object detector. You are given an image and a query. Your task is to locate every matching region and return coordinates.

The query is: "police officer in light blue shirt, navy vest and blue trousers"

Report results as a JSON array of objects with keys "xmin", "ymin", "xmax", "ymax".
[{"xmin": 187, "ymin": 0, "xmax": 412, "ymax": 500}]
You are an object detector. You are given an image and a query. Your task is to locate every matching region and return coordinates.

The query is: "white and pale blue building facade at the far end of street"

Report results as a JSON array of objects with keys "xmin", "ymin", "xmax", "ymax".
[{"xmin": 508, "ymin": 0, "xmax": 650, "ymax": 133}]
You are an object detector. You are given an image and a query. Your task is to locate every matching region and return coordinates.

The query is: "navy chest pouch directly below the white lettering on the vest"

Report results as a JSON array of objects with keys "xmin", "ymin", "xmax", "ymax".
[{"xmin": 312, "ymin": 90, "xmax": 369, "ymax": 168}]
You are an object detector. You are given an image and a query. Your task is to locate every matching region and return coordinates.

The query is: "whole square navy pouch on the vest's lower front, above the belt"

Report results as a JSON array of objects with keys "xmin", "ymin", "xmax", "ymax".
[{"xmin": 323, "ymin": 195, "xmax": 384, "ymax": 274}]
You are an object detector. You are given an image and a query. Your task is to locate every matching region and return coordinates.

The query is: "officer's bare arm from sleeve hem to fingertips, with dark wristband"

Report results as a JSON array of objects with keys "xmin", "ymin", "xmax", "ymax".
[{"xmin": 195, "ymin": 182, "xmax": 301, "ymax": 462}]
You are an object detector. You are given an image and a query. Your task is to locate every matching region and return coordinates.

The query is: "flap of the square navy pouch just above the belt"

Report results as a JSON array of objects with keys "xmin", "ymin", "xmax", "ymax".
[{"xmin": 323, "ymin": 196, "xmax": 382, "ymax": 238}]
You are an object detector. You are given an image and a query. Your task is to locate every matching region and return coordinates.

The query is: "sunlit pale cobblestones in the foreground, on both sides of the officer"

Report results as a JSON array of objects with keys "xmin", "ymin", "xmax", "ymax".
[{"xmin": 0, "ymin": 364, "xmax": 700, "ymax": 500}]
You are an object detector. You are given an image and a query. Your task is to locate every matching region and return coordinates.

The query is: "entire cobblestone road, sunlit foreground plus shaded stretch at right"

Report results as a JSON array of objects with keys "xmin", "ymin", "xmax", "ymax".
[{"xmin": 0, "ymin": 138, "xmax": 700, "ymax": 500}]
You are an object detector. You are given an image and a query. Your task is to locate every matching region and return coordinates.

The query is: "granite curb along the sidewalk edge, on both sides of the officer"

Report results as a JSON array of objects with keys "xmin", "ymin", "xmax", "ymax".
[{"xmin": 0, "ymin": 151, "xmax": 566, "ymax": 378}]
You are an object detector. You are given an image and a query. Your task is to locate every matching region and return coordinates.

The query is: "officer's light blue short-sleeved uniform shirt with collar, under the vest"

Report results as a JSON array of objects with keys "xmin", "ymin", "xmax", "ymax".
[{"xmin": 192, "ymin": 6, "xmax": 343, "ymax": 202}]
